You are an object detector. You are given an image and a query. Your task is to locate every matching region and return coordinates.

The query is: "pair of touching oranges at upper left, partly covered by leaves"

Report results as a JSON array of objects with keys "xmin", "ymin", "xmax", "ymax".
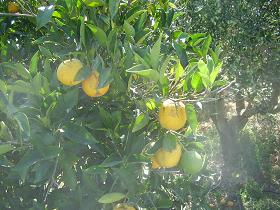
[{"xmin": 57, "ymin": 59, "xmax": 110, "ymax": 97}]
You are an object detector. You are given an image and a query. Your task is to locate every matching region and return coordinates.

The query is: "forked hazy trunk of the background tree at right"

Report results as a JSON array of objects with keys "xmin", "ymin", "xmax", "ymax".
[{"xmin": 212, "ymin": 96, "xmax": 263, "ymax": 190}]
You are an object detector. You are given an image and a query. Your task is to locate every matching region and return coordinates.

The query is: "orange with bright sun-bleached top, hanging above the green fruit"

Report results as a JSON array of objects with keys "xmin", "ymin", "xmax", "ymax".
[{"xmin": 159, "ymin": 99, "xmax": 187, "ymax": 131}]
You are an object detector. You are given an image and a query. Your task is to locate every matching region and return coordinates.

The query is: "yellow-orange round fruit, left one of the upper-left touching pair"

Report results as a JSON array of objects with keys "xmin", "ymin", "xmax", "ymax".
[{"xmin": 56, "ymin": 59, "xmax": 83, "ymax": 86}]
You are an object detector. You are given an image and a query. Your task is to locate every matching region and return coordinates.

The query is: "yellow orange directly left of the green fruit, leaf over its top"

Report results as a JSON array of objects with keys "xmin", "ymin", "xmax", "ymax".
[{"xmin": 154, "ymin": 140, "xmax": 182, "ymax": 168}]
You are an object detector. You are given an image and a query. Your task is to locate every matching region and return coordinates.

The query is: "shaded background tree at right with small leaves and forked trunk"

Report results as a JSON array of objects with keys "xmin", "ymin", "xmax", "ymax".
[{"xmin": 182, "ymin": 0, "xmax": 280, "ymax": 185}]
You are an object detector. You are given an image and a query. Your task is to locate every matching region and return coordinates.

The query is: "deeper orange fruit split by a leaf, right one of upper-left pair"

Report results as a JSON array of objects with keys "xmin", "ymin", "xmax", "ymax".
[{"xmin": 82, "ymin": 71, "xmax": 110, "ymax": 97}]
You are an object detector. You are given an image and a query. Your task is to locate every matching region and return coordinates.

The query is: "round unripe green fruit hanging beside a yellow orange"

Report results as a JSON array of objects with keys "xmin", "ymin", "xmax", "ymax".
[{"xmin": 180, "ymin": 151, "xmax": 203, "ymax": 175}]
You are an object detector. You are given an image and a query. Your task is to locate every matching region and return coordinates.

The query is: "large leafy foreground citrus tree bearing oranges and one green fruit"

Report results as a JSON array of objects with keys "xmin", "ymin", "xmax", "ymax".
[{"xmin": 0, "ymin": 0, "xmax": 227, "ymax": 209}]
